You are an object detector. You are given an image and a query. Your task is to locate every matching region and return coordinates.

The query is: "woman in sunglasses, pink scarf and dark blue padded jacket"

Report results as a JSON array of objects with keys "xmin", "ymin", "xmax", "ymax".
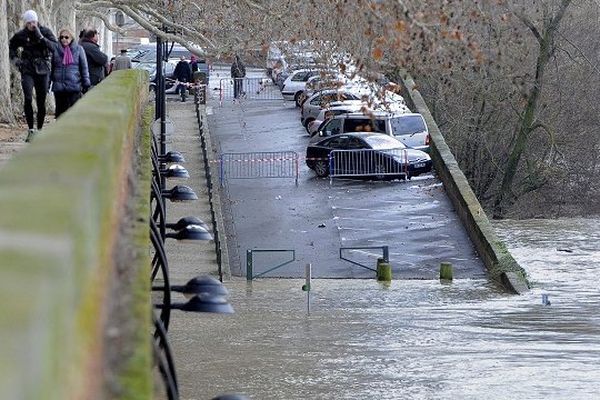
[{"xmin": 52, "ymin": 29, "xmax": 91, "ymax": 118}]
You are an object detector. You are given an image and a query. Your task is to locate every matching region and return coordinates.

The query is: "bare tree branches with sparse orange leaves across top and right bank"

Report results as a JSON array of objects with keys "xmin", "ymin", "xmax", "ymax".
[{"xmin": 8, "ymin": 0, "xmax": 600, "ymax": 217}]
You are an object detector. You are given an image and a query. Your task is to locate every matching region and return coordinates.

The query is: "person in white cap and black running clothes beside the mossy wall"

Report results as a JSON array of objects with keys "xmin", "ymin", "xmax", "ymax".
[{"xmin": 8, "ymin": 10, "xmax": 56, "ymax": 142}]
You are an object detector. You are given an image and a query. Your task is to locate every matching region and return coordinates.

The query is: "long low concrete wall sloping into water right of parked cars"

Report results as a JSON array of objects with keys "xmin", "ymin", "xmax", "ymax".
[{"xmin": 402, "ymin": 74, "xmax": 529, "ymax": 293}]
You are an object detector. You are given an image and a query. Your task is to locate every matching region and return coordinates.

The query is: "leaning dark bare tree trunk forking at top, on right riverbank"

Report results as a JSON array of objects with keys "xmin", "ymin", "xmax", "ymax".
[{"xmin": 493, "ymin": 0, "xmax": 572, "ymax": 218}]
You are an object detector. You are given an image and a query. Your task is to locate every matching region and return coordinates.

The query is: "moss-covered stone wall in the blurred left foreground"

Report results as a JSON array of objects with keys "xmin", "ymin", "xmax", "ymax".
[{"xmin": 0, "ymin": 70, "xmax": 152, "ymax": 400}]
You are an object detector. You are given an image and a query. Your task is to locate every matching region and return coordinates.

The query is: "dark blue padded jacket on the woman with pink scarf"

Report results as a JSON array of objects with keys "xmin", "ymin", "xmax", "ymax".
[{"xmin": 52, "ymin": 41, "xmax": 91, "ymax": 93}]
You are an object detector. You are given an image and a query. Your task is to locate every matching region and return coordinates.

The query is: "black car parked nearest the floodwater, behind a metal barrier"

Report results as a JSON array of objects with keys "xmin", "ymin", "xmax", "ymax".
[{"xmin": 306, "ymin": 132, "xmax": 432, "ymax": 179}]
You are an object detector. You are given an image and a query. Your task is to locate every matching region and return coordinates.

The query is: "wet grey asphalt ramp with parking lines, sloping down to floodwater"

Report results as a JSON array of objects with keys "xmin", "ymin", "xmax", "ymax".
[{"xmin": 209, "ymin": 66, "xmax": 485, "ymax": 279}]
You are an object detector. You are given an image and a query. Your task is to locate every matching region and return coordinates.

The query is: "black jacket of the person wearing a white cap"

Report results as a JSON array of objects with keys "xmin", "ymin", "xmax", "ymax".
[{"xmin": 8, "ymin": 26, "xmax": 57, "ymax": 74}]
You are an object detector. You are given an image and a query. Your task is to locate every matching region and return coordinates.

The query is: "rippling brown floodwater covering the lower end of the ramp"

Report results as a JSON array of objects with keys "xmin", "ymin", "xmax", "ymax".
[{"xmin": 170, "ymin": 220, "xmax": 600, "ymax": 400}]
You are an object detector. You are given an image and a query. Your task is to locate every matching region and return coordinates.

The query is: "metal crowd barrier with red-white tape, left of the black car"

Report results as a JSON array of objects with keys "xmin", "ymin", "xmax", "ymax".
[{"xmin": 219, "ymin": 151, "xmax": 300, "ymax": 186}]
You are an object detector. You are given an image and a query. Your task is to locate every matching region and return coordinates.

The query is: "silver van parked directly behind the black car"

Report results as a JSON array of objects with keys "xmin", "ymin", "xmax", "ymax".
[{"xmin": 315, "ymin": 111, "xmax": 430, "ymax": 152}]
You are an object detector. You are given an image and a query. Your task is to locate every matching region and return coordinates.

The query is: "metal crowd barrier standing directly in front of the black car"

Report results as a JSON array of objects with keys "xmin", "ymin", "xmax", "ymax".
[{"xmin": 329, "ymin": 149, "xmax": 408, "ymax": 180}]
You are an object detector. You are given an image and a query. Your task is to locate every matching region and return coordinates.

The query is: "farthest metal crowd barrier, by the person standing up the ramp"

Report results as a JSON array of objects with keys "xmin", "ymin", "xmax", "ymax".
[{"xmin": 219, "ymin": 78, "xmax": 283, "ymax": 106}]
